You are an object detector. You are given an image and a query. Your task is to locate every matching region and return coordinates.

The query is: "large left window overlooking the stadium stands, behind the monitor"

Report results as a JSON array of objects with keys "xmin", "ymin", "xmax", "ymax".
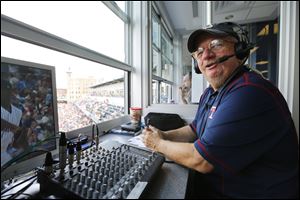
[{"xmin": 1, "ymin": 2, "xmax": 132, "ymax": 134}]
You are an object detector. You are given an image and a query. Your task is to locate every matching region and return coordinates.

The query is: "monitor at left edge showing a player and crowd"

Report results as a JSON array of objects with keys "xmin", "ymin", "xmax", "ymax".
[{"xmin": 1, "ymin": 57, "xmax": 58, "ymax": 182}]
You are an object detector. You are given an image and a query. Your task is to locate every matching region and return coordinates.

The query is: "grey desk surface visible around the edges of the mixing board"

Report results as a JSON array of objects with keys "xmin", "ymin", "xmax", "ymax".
[{"xmin": 1, "ymin": 134, "xmax": 189, "ymax": 199}]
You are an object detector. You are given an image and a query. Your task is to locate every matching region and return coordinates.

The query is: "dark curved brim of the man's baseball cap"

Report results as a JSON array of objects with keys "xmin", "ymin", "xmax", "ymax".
[{"xmin": 187, "ymin": 29, "xmax": 229, "ymax": 53}]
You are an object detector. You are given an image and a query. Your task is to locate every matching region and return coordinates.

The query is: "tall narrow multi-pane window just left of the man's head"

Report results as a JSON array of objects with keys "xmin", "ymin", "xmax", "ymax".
[{"xmin": 151, "ymin": 5, "xmax": 174, "ymax": 104}]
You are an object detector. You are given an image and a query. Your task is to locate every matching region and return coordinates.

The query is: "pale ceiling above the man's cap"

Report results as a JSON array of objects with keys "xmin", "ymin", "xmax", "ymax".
[{"xmin": 163, "ymin": 1, "xmax": 279, "ymax": 36}]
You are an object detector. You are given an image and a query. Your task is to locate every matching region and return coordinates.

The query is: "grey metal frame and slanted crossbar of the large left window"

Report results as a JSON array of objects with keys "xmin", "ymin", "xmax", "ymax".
[{"xmin": 1, "ymin": 2, "xmax": 134, "ymax": 135}]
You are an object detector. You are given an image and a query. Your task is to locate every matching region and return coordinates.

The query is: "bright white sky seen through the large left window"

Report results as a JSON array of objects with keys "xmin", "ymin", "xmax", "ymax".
[{"xmin": 1, "ymin": 1, "xmax": 125, "ymax": 88}]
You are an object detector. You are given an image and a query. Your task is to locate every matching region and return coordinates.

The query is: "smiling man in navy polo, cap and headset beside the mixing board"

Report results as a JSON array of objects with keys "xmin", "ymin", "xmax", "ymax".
[{"xmin": 143, "ymin": 23, "xmax": 299, "ymax": 198}]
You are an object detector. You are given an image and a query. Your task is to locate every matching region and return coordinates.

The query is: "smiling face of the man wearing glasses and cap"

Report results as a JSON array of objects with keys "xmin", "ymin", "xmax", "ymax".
[{"xmin": 197, "ymin": 35, "xmax": 240, "ymax": 90}]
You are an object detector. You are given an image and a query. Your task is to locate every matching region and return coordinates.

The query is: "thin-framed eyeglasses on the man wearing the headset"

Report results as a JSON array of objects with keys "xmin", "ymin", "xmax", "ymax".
[{"xmin": 192, "ymin": 39, "xmax": 234, "ymax": 60}]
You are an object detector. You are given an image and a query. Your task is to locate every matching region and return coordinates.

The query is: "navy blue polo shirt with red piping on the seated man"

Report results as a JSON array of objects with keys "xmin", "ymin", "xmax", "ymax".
[{"xmin": 190, "ymin": 66, "xmax": 299, "ymax": 198}]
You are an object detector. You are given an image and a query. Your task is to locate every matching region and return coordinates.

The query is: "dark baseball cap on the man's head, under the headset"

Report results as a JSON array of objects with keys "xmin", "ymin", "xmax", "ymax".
[{"xmin": 187, "ymin": 22, "xmax": 240, "ymax": 53}]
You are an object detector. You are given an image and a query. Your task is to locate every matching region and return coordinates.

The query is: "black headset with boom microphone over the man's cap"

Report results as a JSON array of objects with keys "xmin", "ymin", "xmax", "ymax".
[{"xmin": 192, "ymin": 22, "xmax": 255, "ymax": 74}]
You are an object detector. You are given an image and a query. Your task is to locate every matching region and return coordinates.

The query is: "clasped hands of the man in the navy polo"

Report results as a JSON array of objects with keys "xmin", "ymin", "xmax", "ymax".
[{"xmin": 142, "ymin": 125, "xmax": 163, "ymax": 151}]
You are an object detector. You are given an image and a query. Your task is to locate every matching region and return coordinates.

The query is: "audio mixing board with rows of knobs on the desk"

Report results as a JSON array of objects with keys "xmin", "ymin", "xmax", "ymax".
[{"xmin": 38, "ymin": 141, "xmax": 164, "ymax": 199}]
